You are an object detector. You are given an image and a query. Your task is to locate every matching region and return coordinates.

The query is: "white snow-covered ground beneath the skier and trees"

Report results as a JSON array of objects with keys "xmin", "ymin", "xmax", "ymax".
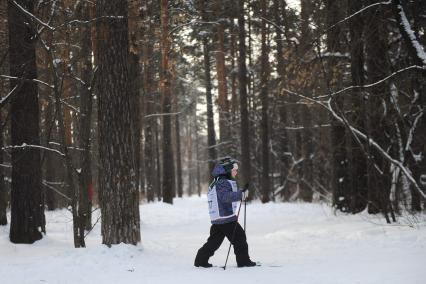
[{"xmin": 0, "ymin": 196, "xmax": 426, "ymax": 284}]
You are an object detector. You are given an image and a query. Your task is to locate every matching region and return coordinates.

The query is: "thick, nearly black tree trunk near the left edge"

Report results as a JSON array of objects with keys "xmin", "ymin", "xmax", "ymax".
[{"xmin": 8, "ymin": 1, "xmax": 45, "ymax": 243}]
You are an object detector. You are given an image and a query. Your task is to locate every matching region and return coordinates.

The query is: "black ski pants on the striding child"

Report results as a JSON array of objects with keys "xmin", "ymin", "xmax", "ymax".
[{"xmin": 195, "ymin": 221, "xmax": 250, "ymax": 265}]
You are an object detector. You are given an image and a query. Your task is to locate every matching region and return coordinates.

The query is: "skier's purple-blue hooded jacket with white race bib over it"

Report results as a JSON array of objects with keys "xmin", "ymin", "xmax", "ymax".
[{"xmin": 207, "ymin": 164, "xmax": 242, "ymax": 224}]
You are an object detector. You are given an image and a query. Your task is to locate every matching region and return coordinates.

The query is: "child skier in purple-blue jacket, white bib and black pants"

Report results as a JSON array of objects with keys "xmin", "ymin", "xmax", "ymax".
[{"xmin": 194, "ymin": 158, "xmax": 256, "ymax": 268}]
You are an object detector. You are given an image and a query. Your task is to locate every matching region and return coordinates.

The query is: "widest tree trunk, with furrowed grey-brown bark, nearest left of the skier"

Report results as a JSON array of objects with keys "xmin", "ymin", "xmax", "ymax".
[{"xmin": 96, "ymin": 0, "xmax": 141, "ymax": 246}]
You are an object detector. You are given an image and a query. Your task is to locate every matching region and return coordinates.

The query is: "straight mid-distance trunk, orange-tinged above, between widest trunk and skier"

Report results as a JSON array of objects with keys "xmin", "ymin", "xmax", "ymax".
[{"xmin": 160, "ymin": 0, "xmax": 175, "ymax": 204}]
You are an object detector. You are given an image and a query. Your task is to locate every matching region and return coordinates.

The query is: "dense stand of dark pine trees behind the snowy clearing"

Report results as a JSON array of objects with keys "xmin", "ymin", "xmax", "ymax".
[{"xmin": 0, "ymin": 0, "xmax": 426, "ymax": 247}]
